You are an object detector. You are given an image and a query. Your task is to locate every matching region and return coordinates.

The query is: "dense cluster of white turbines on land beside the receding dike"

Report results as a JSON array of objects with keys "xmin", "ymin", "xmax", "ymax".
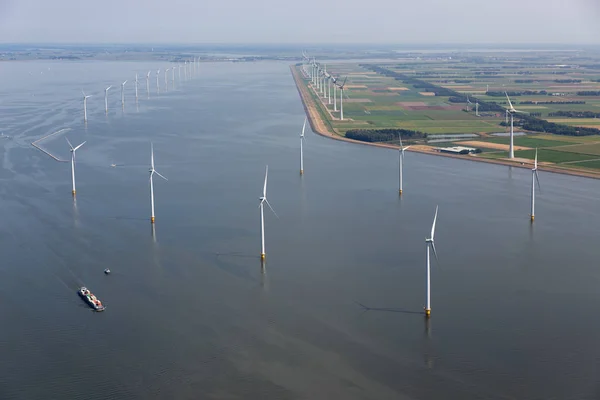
[{"xmin": 302, "ymin": 52, "xmax": 348, "ymax": 121}]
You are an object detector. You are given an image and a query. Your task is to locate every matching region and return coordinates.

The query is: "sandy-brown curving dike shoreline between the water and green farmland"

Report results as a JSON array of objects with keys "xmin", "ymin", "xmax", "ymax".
[{"xmin": 290, "ymin": 64, "xmax": 600, "ymax": 179}]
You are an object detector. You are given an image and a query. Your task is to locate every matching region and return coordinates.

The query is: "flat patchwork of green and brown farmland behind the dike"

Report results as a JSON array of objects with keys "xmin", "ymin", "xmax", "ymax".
[{"xmin": 298, "ymin": 51, "xmax": 600, "ymax": 170}]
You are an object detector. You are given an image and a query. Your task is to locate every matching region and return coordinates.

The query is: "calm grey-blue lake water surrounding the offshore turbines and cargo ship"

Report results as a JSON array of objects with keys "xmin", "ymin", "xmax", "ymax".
[{"xmin": 0, "ymin": 62, "xmax": 600, "ymax": 399}]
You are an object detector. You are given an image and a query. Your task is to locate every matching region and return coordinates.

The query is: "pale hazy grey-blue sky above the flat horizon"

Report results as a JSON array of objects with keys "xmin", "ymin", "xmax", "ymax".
[{"xmin": 0, "ymin": 0, "xmax": 600, "ymax": 44}]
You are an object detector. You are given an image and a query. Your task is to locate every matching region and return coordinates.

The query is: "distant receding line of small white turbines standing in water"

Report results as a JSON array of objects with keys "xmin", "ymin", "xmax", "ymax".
[{"xmin": 81, "ymin": 57, "xmax": 200, "ymax": 123}]
